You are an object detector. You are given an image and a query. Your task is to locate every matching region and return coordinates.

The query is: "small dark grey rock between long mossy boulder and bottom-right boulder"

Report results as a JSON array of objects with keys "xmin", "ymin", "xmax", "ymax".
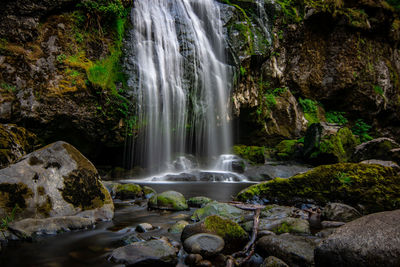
[{"xmin": 322, "ymin": 203, "xmax": 361, "ymax": 222}]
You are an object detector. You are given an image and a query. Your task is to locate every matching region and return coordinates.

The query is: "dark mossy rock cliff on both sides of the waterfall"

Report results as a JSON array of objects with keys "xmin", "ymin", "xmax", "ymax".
[{"xmin": 0, "ymin": 0, "xmax": 400, "ymax": 163}]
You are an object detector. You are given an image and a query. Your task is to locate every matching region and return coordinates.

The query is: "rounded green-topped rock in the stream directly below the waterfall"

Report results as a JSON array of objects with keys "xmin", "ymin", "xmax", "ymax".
[{"xmin": 148, "ymin": 191, "xmax": 189, "ymax": 213}]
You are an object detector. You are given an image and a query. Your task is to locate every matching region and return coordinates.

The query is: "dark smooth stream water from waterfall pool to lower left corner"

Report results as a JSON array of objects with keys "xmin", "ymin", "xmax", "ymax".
[{"xmin": 0, "ymin": 182, "xmax": 251, "ymax": 267}]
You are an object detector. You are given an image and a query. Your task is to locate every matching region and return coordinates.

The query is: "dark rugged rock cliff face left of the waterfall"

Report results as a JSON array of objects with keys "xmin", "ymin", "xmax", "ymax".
[{"xmin": 0, "ymin": 0, "xmax": 125, "ymax": 166}]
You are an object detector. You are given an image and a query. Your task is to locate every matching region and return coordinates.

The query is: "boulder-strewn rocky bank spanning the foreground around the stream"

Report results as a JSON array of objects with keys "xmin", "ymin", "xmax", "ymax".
[{"xmin": 0, "ymin": 142, "xmax": 400, "ymax": 266}]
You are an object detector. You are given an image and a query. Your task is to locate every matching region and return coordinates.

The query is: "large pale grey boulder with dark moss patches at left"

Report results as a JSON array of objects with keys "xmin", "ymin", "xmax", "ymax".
[{"xmin": 0, "ymin": 141, "xmax": 114, "ymax": 220}]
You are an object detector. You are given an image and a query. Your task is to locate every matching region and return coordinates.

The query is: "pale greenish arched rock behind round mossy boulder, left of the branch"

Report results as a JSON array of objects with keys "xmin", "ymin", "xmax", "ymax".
[{"xmin": 192, "ymin": 201, "xmax": 244, "ymax": 221}]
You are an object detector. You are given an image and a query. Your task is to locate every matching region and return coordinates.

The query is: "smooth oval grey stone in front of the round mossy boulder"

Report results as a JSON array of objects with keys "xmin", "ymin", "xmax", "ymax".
[{"xmin": 183, "ymin": 233, "xmax": 225, "ymax": 257}]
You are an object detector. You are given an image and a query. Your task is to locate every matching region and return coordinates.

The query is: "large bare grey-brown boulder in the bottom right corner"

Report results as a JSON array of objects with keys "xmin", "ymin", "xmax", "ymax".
[{"xmin": 315, "ymin": 210, "xmax": 400, "ymax": 267}]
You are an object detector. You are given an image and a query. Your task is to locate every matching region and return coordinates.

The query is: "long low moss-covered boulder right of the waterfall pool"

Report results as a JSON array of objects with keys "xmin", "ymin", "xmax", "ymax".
[{"xmin": 236, "ymin": 163, "xmax": 400, "ymax": 212}]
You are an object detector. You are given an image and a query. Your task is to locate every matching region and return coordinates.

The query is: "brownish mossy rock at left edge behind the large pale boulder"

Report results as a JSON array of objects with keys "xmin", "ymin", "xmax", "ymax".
[{"xmin": 0, "ymin": 124, "xmax": 39, "ymax": 168}]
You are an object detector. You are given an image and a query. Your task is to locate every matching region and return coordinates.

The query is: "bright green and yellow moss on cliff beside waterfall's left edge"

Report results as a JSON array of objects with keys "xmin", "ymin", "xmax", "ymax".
[{"xmin": 57, "ymin": 0, "xmax": 138, "ymax": 135}]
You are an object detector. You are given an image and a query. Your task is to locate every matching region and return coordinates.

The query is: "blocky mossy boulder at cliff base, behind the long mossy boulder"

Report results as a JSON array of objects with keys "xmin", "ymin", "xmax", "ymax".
[{"xmin": 304, "ymin": 123, "xmax": 360, "ymax": 164}]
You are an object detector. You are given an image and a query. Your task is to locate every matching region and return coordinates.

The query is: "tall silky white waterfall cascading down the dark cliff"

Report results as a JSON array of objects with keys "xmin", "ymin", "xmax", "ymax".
[{"xmin": 124, "ymin": 0, "xmax": 232, "ymax": 172}]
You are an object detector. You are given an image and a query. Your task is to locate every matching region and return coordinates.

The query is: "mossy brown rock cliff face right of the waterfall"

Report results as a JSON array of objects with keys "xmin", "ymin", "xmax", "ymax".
[{"xmin": 223, "ymin": 0, "xmax": 400, "ymax": 145}]
